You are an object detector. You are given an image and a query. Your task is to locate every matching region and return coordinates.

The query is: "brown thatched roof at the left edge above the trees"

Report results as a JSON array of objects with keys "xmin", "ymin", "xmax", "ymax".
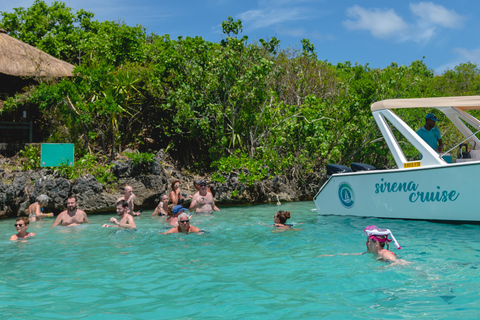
[{"xmin": 0, "ymin": 28, "xmax": 73, "ymax": 78}]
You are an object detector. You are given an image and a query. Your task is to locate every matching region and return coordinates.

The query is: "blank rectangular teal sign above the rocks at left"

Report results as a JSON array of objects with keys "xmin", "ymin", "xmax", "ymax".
[{"xmin": 40, "ymin": 143, "xmax": 75, "ymax": 167}]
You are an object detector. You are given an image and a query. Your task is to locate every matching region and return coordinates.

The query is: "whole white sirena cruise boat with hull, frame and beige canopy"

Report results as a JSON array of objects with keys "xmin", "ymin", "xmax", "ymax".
[{"xmin": 314, "ymin": 96, "xmax": 480, "ymax": 222}]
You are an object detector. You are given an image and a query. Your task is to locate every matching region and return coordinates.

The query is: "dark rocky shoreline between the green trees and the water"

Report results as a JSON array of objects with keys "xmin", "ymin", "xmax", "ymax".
[{"xmin": 0, "ymin": 150, "xmax": 325, "ymax": 218}]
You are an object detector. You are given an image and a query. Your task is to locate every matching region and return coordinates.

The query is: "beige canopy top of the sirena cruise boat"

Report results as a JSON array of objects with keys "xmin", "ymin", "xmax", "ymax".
[{"xmin": 370, "ymin": 96, "xmax": 480, "ymax": 112}]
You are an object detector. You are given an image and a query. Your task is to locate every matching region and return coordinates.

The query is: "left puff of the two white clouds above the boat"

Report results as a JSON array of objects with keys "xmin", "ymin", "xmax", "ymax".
[{"xmin": 343, "ymin": 5, "xmax": 408, "ymax": 39}]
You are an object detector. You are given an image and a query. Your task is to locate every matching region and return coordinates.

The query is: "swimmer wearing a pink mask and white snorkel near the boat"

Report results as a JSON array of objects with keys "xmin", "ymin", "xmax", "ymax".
[{"xmin": 319, "ymin": 226, "xmax": 407, "ymax": 265}]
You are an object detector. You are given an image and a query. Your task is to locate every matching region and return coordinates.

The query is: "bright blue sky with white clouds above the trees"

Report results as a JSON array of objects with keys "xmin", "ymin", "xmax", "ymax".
[{"xmin": 0, "ymin": 0, "xmax": 480, "ymax": 74}]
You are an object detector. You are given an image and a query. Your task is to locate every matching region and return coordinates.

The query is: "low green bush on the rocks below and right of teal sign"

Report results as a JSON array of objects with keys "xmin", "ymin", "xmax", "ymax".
[{"xmin": 55, "ymin": 154, "xmax": 117, "ymax": 187}]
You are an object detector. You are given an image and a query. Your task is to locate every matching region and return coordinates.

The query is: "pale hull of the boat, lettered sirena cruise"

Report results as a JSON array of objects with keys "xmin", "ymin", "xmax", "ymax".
[{"xmin": 314, "ymin": 161, "xmax": 480, "ymax": 222}]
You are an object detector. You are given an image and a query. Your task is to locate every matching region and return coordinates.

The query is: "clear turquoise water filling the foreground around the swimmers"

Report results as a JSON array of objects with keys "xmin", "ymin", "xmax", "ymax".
[{"xmin": 0, "ymin": 202, "xmax": 480, "ymax": 319}]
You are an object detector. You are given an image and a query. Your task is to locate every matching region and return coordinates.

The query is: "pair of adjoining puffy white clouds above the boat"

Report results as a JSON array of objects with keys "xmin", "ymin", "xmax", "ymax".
[{"xmin": 343, "ymin": 2, "xmax": 465, "ymax": 43}]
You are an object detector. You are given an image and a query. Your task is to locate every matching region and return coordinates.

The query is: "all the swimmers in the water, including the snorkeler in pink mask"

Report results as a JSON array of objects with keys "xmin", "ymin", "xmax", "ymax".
[{"xmin": 10, "ymin": 180, "xmax": 405, "ymax": 264}]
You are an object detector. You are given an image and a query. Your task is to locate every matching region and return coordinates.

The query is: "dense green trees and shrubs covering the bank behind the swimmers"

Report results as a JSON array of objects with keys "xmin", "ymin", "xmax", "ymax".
[{"xmin": 0, "ymin": 0, "xmax": 480, "ymax": 183}]
